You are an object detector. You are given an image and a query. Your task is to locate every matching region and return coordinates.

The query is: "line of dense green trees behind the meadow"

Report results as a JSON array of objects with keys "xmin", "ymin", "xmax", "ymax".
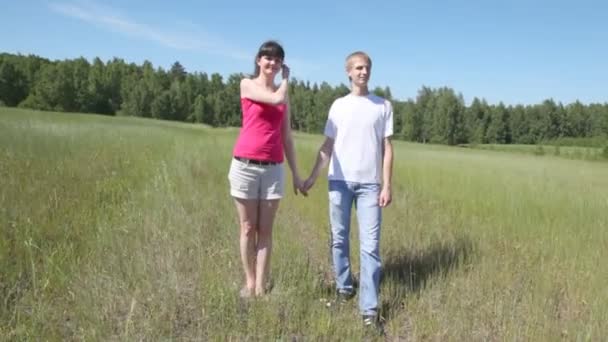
[{"xmin": 0, "ymin": 53, "xmax": 608, "ymax": 145}]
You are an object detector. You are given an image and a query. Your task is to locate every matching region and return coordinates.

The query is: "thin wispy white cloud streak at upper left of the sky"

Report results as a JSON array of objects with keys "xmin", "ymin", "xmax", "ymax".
[{"xmin": 49, "ymin": 2, "xmax": 251, "ymax": 60}]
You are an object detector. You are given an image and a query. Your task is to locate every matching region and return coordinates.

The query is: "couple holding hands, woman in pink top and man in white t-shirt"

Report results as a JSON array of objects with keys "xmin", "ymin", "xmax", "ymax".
[{"xmin": 228, "ymin": 41, "xmax": 393, "ymax": 326}]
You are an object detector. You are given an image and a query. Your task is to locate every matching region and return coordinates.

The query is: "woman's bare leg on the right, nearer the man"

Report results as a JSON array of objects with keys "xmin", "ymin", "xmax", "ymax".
[{"xmin": 255, "ymin": 200, "xmax": 279, "ymax": 295}]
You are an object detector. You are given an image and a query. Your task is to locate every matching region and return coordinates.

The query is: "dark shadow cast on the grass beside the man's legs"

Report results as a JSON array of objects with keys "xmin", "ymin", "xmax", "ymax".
[{"xmin": 380, "ymin": 237, "xmax": 475, "ymax": 320}]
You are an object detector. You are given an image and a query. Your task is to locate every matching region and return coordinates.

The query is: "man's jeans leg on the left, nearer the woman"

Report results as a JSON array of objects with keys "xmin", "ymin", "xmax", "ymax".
[{"xmin": 329, "ymin": 181, "xmax": 353, "ymax": 293}]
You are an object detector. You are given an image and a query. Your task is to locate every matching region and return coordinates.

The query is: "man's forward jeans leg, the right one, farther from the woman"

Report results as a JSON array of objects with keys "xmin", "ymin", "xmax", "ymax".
[{"xmin": 355, "ymin": 184, "xmax": 381, "ymax": 315}]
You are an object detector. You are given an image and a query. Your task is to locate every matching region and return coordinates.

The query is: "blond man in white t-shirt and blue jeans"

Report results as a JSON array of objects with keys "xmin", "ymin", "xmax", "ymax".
[{"xmin": 304, "ymin": 51, "xmax": 393, "ymax": 328}]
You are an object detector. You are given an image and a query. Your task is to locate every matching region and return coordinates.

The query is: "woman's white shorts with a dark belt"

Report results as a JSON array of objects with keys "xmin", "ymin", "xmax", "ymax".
[{"xmin": 228, "ymin": 158, "xmax": 285, "ymax": 200}]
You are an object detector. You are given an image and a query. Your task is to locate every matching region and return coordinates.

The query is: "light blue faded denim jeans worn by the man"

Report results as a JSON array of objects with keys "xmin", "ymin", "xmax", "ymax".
[{"xmin": 329, "ymin": 180, "xmax": 382, "ymax": 315}]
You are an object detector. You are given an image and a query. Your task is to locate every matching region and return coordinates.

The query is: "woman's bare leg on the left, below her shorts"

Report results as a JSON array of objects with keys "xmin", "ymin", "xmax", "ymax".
[{"xmin": 234, "ymin": 198, "xmax": 260, "ymax": 296}]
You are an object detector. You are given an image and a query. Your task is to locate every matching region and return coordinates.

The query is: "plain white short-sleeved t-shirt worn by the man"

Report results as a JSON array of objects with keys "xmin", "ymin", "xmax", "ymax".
[{"xmin": 325, "ymin": 94, "xmax": 393, "ymax": 184}]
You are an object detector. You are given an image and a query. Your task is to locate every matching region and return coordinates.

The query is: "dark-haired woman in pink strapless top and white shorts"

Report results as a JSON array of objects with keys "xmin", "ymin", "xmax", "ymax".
[{"xmin": 228, "ymin": 41, "xmax": 306, "ymax": 298}]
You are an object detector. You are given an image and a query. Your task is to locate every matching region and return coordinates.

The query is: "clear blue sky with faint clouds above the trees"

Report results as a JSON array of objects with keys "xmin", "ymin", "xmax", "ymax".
[{"xmin": 0, "ymin": 0, "xmax": 608, "ymax": 104}]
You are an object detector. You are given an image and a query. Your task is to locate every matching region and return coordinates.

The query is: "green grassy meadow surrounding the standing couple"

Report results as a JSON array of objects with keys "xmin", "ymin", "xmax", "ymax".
[{"xmin": 0, "ymin": 108, "xmax": 608, "ymax": 341}]
